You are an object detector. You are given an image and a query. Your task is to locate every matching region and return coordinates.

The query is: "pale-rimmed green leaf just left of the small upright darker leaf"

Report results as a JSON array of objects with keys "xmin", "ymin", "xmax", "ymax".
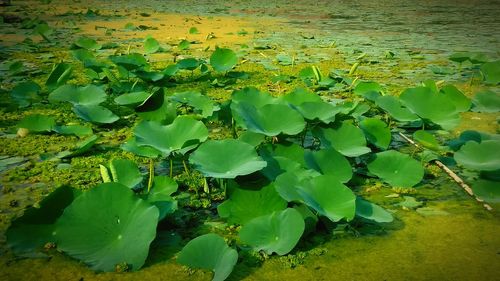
[{"xmin": 313, "ymin": 121, "xmax": 371, "ymax": 157}]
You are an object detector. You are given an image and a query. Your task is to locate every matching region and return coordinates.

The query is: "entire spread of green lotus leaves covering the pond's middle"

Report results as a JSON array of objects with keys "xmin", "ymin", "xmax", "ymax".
[{"xmin": 7, "ymin": 33, "xmax": 500, "ymax": 280}]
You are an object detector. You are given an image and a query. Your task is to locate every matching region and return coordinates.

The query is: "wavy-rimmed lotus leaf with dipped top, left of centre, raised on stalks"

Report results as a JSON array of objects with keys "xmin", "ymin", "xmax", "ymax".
[{"xmin": 134, "ymin": 116, "xmax": 208, "ymax": 156}]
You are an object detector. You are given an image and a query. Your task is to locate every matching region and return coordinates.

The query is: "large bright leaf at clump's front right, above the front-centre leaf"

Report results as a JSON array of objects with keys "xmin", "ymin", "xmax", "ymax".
[{"xmin": 297, "ymin": 175, "xmax": 356, "ymax": 222}]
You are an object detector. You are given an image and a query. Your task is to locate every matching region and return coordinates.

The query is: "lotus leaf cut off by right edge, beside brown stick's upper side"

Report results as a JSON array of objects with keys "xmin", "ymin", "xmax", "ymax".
[{"xmin": 454, "ymin": 140, "xmax": 500, "ymax": 171}]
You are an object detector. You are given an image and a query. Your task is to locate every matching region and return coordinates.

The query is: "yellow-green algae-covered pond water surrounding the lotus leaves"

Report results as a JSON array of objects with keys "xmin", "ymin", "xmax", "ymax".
[{"xmin": 0, "ymin": 0, "xmax": 500, "ymax": 280}]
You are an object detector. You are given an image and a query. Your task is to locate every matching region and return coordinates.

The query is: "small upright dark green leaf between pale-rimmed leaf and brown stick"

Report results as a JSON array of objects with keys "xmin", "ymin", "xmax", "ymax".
[{"xmin": 359, "ymin": 118, "xmax": 391, "ymax": 150}]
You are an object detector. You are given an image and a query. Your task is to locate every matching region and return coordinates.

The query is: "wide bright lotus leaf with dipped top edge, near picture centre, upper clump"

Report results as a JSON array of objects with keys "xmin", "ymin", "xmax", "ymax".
[{"xmin": 231, "ymin": 102, "xmax": 306, "ymax": 136}]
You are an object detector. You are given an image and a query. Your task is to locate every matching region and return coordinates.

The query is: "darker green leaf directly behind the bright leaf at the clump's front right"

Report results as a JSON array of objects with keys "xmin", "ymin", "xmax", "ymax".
[{"xmin": 305, "ymin": 148, "xmax": 352, "ymax": 183}]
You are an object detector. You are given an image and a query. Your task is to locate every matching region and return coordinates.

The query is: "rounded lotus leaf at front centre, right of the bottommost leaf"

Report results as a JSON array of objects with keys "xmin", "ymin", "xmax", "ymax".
[{"xmin": 240, "ymin": 208, "xmax": 305, "ymax": 255}]
